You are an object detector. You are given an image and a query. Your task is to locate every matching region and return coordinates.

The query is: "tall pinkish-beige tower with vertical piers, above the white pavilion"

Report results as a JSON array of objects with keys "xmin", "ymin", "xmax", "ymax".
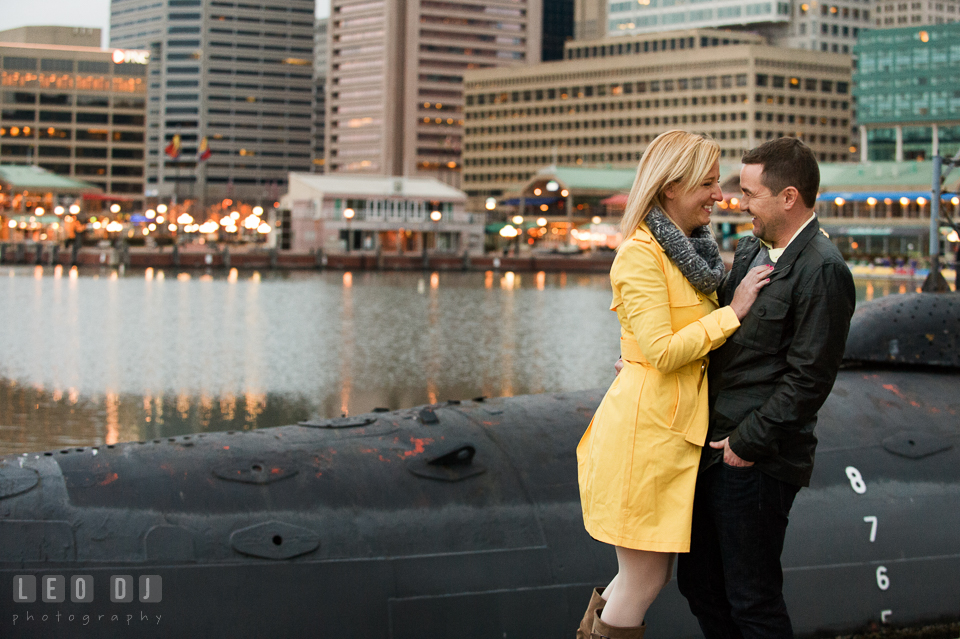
[{"xmin": 326, "ymin": 0, "xmax": 543, "ymax": 186}]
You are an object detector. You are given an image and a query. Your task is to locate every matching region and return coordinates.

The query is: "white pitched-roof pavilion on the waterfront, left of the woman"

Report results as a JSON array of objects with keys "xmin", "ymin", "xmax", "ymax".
[{"xmin": 277, "ymin": 173, "xmax": 485, "ymax": 255}]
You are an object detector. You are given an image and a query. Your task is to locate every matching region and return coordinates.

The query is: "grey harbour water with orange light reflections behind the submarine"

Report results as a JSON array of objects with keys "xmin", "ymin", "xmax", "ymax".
[{"xmin": 0, "ymin": 267, "xmax": 932, "ymax": 453}]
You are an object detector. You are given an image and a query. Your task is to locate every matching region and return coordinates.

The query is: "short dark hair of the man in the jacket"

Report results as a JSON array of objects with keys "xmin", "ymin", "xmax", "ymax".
[{"xmin": 741, "ymin": 138, "xmax": 820, "ymax": 209}]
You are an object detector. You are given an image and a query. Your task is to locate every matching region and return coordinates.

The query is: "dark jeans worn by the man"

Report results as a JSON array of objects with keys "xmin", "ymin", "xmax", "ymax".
[{"xmin": 677, "ymin": 464, "xmax": 800, "ymax": 639}]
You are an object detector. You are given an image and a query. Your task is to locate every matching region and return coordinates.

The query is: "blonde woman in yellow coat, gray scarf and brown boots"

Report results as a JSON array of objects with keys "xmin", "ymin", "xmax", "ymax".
[{"xmin": 577, "ymin": 131, "xmax": 770, "ymax": 639}]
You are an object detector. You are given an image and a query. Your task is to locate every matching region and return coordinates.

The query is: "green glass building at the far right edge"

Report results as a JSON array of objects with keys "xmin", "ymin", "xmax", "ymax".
[{"xmin": 853, "ymin": 22, "xmax": 960, "ymax": 161}]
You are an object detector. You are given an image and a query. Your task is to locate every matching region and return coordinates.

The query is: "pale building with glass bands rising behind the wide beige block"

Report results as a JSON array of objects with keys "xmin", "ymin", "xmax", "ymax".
[{"xmin": 604, "ymin": 0, "xmax": 873, "ymax": 53}]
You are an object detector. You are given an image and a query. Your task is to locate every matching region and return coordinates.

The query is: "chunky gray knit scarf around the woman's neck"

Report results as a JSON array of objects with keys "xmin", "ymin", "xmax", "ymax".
[{"xmin": 645, "ymin": 208, "xmax": 724, "ymax": 295}]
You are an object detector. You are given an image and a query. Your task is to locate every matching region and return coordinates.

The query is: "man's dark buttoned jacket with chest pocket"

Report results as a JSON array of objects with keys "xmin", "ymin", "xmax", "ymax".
[{"xmin": 703, "ymin": 220, "xmax": 856, "ymax": 486}]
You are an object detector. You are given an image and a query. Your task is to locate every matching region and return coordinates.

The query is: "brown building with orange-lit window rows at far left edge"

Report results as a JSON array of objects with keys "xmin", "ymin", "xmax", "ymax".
[{"xmin": 0, "ymin": 27, "xmax": 147, "ymax": 197}]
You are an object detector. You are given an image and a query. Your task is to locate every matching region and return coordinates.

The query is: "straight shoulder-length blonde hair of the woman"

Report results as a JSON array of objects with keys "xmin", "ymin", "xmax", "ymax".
[{"xmin": 620, "ymin": 131, "xmax": 720, "ymax": 247}]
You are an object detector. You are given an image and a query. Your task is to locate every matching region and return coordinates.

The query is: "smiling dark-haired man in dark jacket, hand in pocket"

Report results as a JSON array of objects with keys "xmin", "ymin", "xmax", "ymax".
[{"xmin": 677, "ymin": 138, "xmax": 855, "ymax": 639}]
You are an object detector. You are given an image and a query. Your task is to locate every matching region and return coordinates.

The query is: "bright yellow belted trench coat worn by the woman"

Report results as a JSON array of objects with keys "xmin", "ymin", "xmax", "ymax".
[{"xmin": 577, "ymin": 224, "xmax": 740, "ymax": 552}]
